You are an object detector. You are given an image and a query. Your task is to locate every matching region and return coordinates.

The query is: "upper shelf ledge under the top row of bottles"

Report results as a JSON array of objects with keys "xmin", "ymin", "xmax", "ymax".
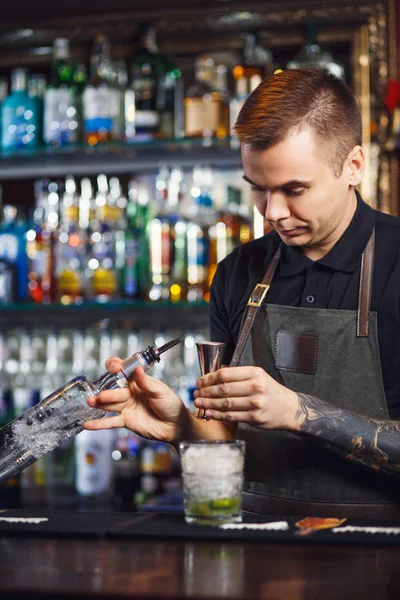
[{"xmin": 0, "ymin": 138, "xmax": 241, "ymax": 180}]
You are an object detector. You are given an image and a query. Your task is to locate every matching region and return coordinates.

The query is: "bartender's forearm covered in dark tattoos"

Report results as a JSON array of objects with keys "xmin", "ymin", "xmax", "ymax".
[{"xmin": 296, "ymin": 394, "xmax": 400, "ymax": 477}]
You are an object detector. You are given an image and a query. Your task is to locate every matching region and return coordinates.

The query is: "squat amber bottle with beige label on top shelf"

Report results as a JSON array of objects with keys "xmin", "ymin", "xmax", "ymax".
[{"xmin": 184, "ymin": 56, "xmax": 229, "ymax": 140}]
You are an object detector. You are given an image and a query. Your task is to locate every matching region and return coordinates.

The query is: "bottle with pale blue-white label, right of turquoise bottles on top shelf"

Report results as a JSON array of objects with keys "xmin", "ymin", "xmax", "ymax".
[{"xmin": 43, "ymin": 38, "xmax": 80, "ymax": 146}]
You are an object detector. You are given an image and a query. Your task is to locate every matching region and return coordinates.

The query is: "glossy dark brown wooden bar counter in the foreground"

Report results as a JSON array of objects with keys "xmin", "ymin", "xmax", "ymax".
[{"xmin": 0, "ymin": 510, "xmax": 400, "ymax": 600}]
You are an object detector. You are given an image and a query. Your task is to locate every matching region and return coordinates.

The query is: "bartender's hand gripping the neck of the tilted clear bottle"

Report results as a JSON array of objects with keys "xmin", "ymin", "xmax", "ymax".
[{"xmin": 84, "ymin": 357, "xmax": 190, "ymax": 443}]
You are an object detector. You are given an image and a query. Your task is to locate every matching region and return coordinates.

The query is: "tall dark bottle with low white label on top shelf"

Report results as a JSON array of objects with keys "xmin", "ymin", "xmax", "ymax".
[{"xmin": 131, "ymin": 23, "xmax": 164, "ymax": 139}]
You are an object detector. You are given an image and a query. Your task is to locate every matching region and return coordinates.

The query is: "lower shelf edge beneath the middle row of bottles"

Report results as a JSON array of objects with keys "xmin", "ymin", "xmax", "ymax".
[{"xmin": 0, "ymin": 300, "xmax": 208, "ymax": 330}]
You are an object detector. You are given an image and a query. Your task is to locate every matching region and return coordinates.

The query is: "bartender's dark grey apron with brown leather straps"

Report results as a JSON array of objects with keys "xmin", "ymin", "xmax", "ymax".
[{"xmin": 230, "ymin": 232, "xmax": 400, "ymax": 518}]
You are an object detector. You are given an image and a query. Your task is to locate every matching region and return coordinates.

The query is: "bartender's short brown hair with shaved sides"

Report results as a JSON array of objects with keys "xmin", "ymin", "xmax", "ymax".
[{"xmin": 234, "ymin": 69, "xmax": 361, "ymax": 177}]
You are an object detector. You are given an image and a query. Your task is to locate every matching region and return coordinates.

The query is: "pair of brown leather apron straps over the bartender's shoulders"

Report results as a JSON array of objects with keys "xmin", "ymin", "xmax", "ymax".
[{"xmin": 229, "ymin": 229, "xmax": 375, "ymax": 367}]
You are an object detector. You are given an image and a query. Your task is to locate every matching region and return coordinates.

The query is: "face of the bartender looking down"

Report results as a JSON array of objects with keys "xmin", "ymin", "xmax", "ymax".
[{"xmin": 242, "ymin": 130, "xmax": 356, "ymax": 260}]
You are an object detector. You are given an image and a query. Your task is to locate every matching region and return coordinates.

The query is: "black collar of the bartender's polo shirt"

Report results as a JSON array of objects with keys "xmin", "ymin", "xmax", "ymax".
[{"xmin": 280, "ymin": 191, "xmax": 375, "ymax": 277}]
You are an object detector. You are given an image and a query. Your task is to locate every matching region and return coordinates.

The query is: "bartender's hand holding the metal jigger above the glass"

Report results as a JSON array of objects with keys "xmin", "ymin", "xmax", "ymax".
[{"xmin": 194, "ymin": 367, "xmax": 299, "ymax": 431}]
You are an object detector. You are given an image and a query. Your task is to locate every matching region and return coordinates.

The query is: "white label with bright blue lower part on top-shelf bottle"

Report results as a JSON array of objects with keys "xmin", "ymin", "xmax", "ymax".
[{"xmin": 83, "ymin": 87, "xmax": 113, "ymax": 133}]
